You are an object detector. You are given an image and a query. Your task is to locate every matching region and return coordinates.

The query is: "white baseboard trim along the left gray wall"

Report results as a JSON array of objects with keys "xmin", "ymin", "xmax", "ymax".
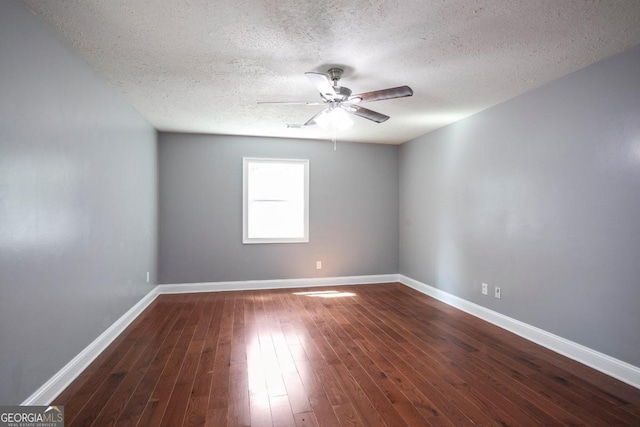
[{"xmin": 21, "ymin": 286, "xmax": 158, "ymax": 406}]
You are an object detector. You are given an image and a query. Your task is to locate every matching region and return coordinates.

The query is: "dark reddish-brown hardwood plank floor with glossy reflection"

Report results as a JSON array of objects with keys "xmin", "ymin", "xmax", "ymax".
[{"xmin": 55, "ymin": 283, "xmax": 640, "ymax": 427}]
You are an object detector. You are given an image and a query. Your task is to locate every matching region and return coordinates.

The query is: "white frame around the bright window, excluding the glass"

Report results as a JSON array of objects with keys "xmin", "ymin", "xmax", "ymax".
[{"xmin": 242, "ymin": 157, "xmax": 309, "ymax": 244}]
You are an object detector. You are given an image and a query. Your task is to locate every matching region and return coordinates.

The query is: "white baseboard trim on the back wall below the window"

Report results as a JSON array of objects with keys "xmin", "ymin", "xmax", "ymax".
[{"xmin": 157, "ymin": 274, "xmax": 400, "ymax": 294}]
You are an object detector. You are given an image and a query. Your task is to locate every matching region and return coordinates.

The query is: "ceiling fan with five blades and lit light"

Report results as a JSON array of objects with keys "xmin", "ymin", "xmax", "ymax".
[{"xmin": 258, "ymin": 68, "xmax": 413, "ymax": 127}]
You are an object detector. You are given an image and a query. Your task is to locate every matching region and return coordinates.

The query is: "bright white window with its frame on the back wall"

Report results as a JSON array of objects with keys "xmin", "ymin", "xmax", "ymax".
[{"xmin": 242, "ymin": 157, "xmax": 309, "ymax": 243}]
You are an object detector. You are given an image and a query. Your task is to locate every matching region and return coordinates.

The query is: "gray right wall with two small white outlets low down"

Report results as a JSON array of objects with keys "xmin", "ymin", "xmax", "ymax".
[{"xmin": 400, "ymin": 48, "xmax": 640, "ymax": 366}]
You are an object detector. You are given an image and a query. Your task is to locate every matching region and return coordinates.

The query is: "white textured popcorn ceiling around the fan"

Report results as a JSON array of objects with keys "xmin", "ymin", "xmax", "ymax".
[{"xmin": 25, "ymin": 0, "xmax": 640, "ymax": 143}]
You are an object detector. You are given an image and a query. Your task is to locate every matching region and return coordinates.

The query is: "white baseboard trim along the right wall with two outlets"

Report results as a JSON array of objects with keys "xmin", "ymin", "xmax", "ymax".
[{"xmin": 398, "ymin": 274, "xmax": 640, "ymax": 388}]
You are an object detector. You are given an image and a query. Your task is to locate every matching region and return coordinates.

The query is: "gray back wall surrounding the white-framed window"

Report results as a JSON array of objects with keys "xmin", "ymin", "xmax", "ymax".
[{"xmin": 159, "ymin": 133, "xmax": 398, "ymax": 283}]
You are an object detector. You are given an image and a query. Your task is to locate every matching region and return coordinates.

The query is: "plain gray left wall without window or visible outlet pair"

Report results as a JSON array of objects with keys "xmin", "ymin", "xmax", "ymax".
[{"xmin": 0, "ymin": 0, "xmax": 157, "ymax": 405}]
